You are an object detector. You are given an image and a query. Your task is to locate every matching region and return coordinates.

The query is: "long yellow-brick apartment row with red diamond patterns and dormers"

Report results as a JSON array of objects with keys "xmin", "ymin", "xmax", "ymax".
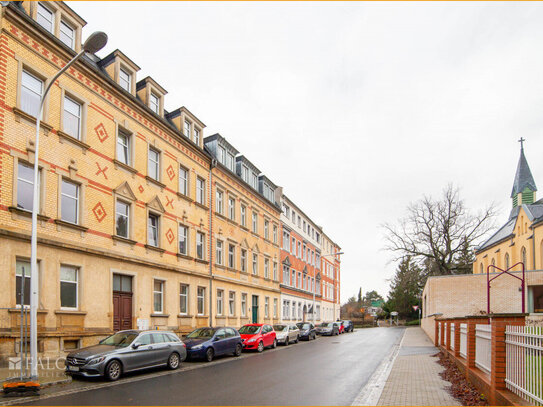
[{"xmin": 0, "ymin": 1, "xmax": 342, "ymax": 364}]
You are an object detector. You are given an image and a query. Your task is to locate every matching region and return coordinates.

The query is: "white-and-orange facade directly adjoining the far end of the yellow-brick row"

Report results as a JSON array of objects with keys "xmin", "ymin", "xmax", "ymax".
[{"xmin": 281, "ymin": 194, "xmax": 322, "ymax": 323}]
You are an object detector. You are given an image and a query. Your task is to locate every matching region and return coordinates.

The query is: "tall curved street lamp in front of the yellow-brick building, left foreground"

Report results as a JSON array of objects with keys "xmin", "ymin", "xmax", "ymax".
[{"xmin": 28, "ymin": 31, "xmax": 107, "ymax": 378}]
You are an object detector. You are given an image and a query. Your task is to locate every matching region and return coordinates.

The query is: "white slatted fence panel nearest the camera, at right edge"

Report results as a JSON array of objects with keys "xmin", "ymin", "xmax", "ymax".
[{"xmin": 505, "ymin": 326, "xmax": 543, "ymax": 406}]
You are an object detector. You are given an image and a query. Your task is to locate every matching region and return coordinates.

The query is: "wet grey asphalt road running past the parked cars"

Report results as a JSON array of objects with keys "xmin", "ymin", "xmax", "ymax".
[{"xmin": 20, "ymin": 328, "xmax": 403, "ymax": 405}]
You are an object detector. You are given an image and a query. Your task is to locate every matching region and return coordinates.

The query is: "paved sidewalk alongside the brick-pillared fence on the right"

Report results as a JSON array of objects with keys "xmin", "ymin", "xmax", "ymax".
[{"xmin": 377, "ymin": 327, "xmax": 461, "ymax": 406}]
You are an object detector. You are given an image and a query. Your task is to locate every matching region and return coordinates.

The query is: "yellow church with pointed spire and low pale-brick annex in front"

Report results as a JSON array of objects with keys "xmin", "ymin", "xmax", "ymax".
[{"xmin": 422, "ymin": 148, "xmax": 543, "ymax": 338}]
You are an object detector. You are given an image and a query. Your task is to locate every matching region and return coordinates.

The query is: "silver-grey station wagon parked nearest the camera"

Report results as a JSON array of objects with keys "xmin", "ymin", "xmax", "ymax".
[{"xmin": 65, "ymin": 330, "xmax": 187, "ymax": 380}]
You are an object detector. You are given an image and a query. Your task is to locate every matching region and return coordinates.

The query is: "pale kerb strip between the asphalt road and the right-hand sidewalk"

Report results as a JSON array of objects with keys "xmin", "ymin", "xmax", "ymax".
[{"xmin": 351, "ymin": 329, "xmax": 406, "ymax": 406}]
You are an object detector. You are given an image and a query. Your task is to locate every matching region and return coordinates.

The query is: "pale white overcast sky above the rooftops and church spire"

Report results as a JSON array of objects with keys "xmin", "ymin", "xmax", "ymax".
[{"xmin": 69, "ymin": 2, "xmax": 543, "ymax": 301}]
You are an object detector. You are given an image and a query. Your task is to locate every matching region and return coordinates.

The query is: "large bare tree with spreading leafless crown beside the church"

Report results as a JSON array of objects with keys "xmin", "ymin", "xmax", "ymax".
[{"xmin": 383, "ymin": 184, "xmax": 496, "ymax": 280}]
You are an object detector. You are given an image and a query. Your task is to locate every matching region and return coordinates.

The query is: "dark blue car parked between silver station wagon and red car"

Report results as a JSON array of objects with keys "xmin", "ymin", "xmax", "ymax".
[{"xmin": 185, "ymin": 327, "xmax": 243, "ymax": 362}]
